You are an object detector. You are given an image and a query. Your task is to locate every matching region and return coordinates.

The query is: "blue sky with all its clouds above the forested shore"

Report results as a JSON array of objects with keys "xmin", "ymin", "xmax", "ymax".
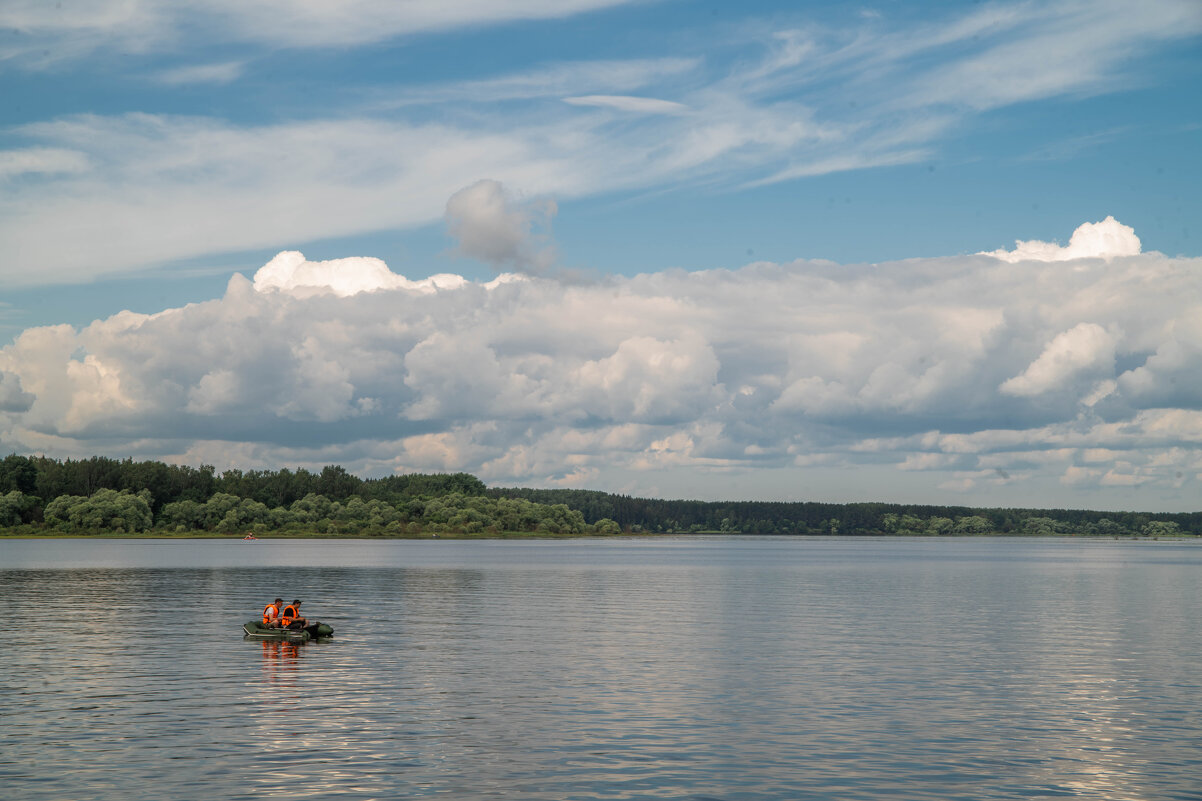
[{"xmin": 0, "ymin": 0, "xmax": 1202, "ymax": 511}]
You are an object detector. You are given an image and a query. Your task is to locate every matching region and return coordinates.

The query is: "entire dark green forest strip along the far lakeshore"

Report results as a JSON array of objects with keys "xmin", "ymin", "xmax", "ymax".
[{"xmin": 0, "ymin": 453, "xmax": 1202, "ymax": 538}]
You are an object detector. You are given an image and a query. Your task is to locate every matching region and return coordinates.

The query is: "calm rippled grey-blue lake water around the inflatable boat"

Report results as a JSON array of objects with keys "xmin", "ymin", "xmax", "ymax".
[{"xmin": 0, "ymin": 538, "xmax": 1202, "ymax": 801}]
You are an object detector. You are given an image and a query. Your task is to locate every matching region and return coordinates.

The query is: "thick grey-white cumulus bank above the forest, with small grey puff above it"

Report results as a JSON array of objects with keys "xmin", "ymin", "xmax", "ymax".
[{"xmin": 0, "ymin": 209, "xmax": 1202, "ymax": 509}]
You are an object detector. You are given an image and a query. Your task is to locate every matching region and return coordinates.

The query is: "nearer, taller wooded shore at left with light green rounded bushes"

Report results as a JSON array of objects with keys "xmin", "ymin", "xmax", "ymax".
[{"xmin": 0, "ymin": 453, "xmax": 605, "ymax": 536}]
